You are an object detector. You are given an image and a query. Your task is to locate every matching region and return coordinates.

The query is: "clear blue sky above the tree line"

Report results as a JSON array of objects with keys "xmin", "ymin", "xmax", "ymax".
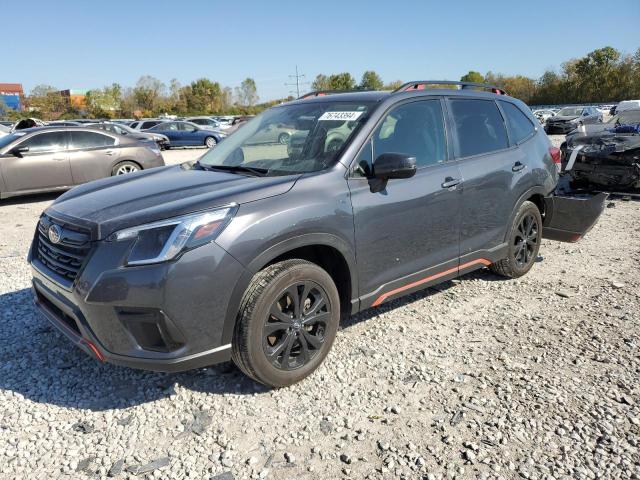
[{"xmin": 0, "ymin": 0, "xmax": 640, "ymax": 100}]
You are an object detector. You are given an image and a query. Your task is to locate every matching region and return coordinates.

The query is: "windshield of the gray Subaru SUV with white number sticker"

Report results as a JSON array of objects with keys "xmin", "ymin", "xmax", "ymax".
[{"xmin": 199, "ymin": 102, "xmax": 372, "ymax": 175}]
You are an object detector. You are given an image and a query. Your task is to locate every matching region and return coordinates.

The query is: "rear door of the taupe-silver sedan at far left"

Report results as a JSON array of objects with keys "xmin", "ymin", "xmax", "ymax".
[{"xmin": 69, "ymin": 130, "xmax": 120, "ymax": 185}]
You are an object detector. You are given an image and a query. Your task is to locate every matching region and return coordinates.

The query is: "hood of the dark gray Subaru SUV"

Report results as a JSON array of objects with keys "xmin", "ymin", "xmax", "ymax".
[{"xmin": 46, "ymin": 164, "xmax": 299, "ymax": 240}]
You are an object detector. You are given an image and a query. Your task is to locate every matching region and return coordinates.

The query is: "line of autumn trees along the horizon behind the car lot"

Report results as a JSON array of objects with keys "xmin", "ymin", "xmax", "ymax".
[{"xmin": 0, "ymin": 47, "xmax": 640, "ymax": 120}]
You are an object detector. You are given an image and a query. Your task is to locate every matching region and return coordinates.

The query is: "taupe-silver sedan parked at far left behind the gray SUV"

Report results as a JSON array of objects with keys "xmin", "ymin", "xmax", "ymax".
[{"xmin": 0, "ymin": 127, "xmax": 164, "ymax": 198}]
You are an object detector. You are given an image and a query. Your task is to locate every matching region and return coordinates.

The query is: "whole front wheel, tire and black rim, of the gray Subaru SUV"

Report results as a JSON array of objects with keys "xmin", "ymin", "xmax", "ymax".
[{"xmin": 232, "ymin": 259, "xmax": 340, "ymax": 387}]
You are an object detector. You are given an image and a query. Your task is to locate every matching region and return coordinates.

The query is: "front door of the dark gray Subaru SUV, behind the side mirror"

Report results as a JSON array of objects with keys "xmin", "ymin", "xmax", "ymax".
[{"xmin": 348, "ymin": 99, "xmax": 462, "ymax": 308}]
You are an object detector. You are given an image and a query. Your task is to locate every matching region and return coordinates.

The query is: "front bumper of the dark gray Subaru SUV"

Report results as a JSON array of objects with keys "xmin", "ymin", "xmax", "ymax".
[{"xmin": 29, "ymin": 235, "xmax": 244, "ymax": 372}]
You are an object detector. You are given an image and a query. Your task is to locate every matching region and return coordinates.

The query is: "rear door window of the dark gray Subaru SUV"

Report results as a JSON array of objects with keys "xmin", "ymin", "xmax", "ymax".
[{"xmin": 449, "ymin": 98, "xmax": 509, "ymax": 157}]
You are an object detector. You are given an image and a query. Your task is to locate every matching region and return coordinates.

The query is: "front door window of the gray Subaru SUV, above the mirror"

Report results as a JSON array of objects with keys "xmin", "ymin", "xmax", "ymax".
[{"xmin": 373, "ymin": 100, "xmax": 447, "ymax": 168}]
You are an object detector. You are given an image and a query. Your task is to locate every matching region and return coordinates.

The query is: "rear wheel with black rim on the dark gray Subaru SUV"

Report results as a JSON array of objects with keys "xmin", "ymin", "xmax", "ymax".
[{"xmin": 489, "ymin": 201, "xmax": 542, "ymax": 278}]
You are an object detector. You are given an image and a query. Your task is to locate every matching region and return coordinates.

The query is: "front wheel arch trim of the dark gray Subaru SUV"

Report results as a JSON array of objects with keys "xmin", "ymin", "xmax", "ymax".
[{"xmin": 223, "ymin": 233, "xmax": 358, "ymax": 343}]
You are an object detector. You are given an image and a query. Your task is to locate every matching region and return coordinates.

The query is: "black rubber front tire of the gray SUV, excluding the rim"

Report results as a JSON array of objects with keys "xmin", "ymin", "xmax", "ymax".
[{"xmin": 239, "ymin": 263, "xmax": 340, "ymax": 387}]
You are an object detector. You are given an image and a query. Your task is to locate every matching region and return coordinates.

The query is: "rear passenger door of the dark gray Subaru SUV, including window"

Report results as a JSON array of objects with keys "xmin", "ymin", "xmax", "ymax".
[{"xmin": 448, "ymin": 97, "xmax": 535, "ymax": 258}]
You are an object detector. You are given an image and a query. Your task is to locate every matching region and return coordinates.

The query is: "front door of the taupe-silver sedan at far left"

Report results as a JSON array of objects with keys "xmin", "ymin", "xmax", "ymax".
[{"xmin": 0, "ymin": 131, "xmax": 73, "ymax": 192}]
